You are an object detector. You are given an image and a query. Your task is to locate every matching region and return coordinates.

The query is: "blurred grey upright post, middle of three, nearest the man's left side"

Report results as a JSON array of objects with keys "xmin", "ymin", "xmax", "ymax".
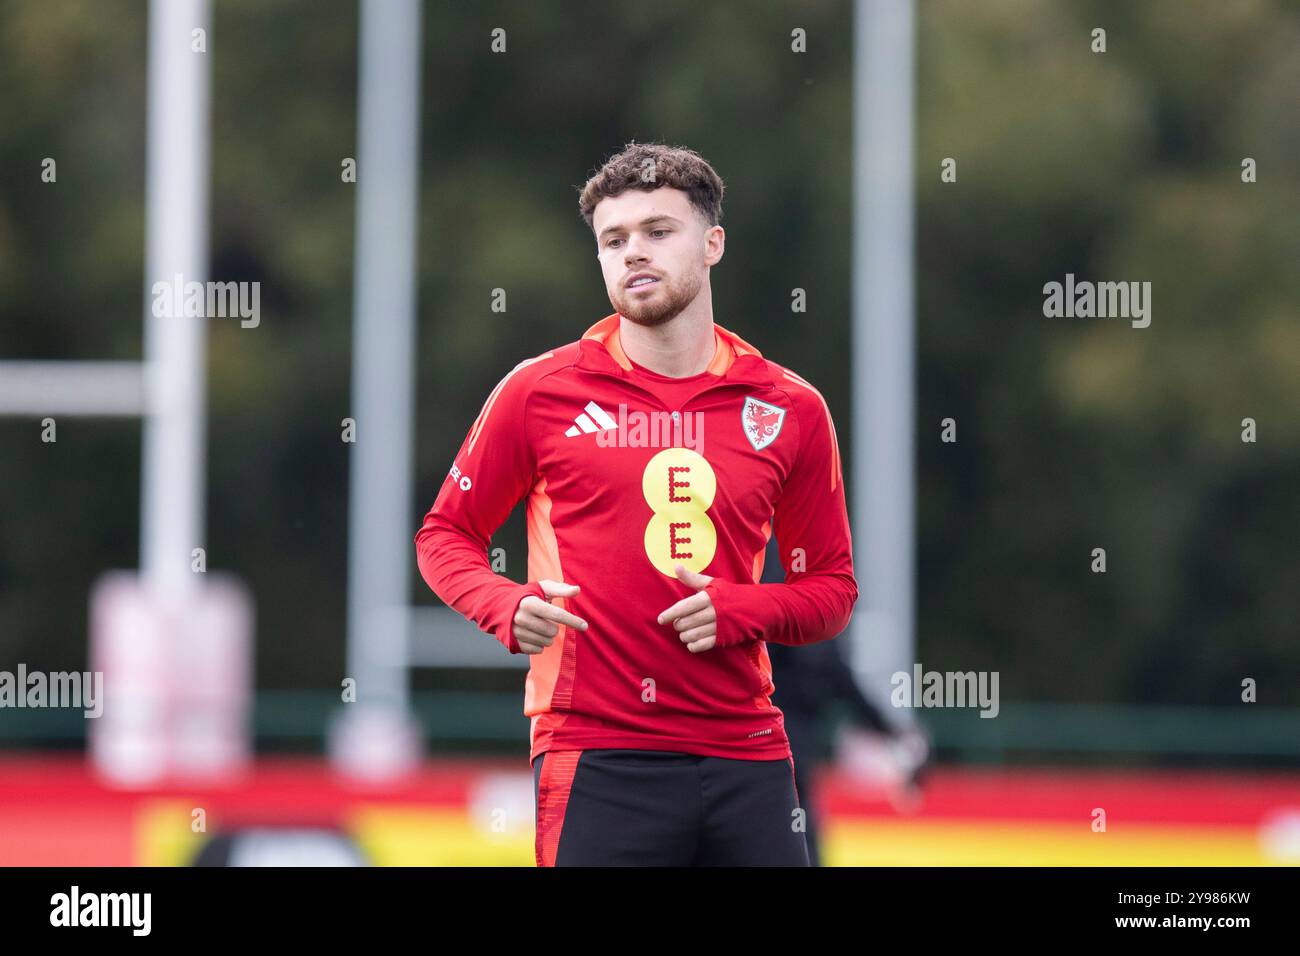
[{"xmin": 332, "ymin": 0, "xmax": 421, "ymax": 777}]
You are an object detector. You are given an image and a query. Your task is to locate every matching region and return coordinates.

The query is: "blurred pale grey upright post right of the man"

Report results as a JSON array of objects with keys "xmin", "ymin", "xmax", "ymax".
[{"xmin": 852, "ymin": 0, "xmax": 915, "ymax": 723}]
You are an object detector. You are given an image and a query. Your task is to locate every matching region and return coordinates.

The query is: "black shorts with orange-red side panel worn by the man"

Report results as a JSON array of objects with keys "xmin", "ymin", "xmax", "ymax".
[{"xmin": 533, "ymin": 749, "xmax": 809, "ymax": 866}]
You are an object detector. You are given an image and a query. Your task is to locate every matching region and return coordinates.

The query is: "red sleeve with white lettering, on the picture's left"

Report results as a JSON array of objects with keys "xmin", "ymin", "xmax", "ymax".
[{"xmin": 415, "ymin": 359, "xmax": 545, "ymax": 654}]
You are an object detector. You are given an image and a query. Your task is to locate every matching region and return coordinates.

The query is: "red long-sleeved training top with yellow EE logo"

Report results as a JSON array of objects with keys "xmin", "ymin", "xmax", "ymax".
[{"xmin": 415, "ymin": 313, "xmax": 858, "ymax": 760}]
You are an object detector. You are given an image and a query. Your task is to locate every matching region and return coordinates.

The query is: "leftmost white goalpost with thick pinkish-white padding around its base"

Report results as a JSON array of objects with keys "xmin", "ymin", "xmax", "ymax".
[{"xmin": 94, "ymin": 0, "xmax": 252, "ymax": 786}]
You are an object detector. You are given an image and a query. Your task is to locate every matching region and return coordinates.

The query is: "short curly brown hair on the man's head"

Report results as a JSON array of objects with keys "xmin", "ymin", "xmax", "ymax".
[{"xmin": 577, "ymin": 142, "xmax": 724, "ymax": 233}]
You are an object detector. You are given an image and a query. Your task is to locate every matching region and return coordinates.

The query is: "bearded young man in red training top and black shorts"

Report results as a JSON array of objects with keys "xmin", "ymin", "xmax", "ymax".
[{"xmin": 416, "ymin": 144, "xmax": 858, "ymax": 866}]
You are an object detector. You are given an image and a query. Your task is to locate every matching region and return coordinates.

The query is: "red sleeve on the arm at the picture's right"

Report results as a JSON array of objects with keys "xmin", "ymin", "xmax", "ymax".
[{"xmin": 706, "ymin": 386, "xmax": 858, "ymax": 648}]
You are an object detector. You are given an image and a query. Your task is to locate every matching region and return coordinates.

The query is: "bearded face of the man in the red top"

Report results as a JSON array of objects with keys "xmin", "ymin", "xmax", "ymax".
[{"xmin": 592, "ymin": 186, "xmax": 725, "ymax": 325}]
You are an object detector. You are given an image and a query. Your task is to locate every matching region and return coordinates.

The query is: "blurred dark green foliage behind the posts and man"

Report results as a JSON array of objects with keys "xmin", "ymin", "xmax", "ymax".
[{"xmin": 0, "ymin": 0, "xmax": 1300, "ymax": 733}]
